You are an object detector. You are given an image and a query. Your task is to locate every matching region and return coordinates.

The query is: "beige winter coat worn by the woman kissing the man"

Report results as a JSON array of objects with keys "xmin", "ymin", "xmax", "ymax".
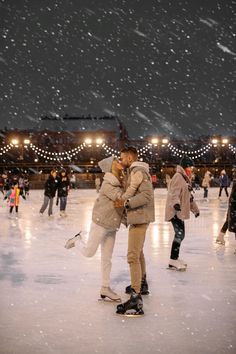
[{"xmin": 92, "ymin": 172, "xmax": 124, "ymax": 230}]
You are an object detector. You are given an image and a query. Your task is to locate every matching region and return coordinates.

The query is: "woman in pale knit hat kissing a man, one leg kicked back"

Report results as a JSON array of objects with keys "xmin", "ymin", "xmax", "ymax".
[{"xmin": 65, "ymin": 156, "xmax": 123, "ymax": 301}]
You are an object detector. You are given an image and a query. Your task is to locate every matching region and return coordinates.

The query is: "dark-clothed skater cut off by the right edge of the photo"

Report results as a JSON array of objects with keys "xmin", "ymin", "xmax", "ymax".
[{"xmin": 216, "ymin": 179, "xmax": 236, "ymax": 253}]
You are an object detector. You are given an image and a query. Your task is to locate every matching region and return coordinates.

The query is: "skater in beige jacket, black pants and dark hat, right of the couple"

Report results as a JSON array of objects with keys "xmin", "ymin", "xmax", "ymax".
[{"xmin": 165, "ymin": 156, "xmax": 199, "ymax": 270}]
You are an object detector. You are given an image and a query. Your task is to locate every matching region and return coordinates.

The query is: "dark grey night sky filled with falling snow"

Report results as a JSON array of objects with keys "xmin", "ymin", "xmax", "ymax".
[{"xmin": 0, "ymin": 0, "xmax": 236, "ymax": 139}]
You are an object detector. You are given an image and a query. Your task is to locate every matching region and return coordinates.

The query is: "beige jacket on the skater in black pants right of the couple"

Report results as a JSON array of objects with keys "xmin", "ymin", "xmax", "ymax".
[{"xmin": 165, "ymin": 165, "xmax": 199, "ymax": 221}]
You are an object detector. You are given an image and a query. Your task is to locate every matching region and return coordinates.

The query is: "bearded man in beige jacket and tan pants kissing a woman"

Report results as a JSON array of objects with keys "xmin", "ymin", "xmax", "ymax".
[{"xmin": 115, "ymin": 146, "xmax": 155, "ymax": 315}]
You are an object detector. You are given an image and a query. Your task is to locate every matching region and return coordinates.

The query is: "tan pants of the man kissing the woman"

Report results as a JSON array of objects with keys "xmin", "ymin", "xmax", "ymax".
[{"xmin": 127, "ymin": 224, "xmax": 149, "ymax": 293}]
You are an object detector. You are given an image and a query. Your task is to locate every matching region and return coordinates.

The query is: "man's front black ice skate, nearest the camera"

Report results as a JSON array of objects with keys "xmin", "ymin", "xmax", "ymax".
[{"xmin": 116, "ymin": 289, "xmax": 144, "ymax": 317}]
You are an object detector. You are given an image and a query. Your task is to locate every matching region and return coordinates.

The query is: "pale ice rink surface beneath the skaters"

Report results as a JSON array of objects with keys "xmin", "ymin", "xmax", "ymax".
[{"xmin": 0, "ymin": 188, "xmax": 236, "ymax": 354}]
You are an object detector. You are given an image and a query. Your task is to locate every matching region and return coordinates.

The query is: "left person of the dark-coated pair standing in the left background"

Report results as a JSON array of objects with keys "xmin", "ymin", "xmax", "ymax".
[{"xmin": 39, "ymin": 169, "xmax": 58, "ymax": 216}]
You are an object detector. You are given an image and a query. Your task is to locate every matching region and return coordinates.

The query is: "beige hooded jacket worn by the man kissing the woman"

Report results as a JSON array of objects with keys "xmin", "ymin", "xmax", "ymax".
[{"xmin": 122, "ymin": 161, "xmax": 155, "ymax": 225}]
